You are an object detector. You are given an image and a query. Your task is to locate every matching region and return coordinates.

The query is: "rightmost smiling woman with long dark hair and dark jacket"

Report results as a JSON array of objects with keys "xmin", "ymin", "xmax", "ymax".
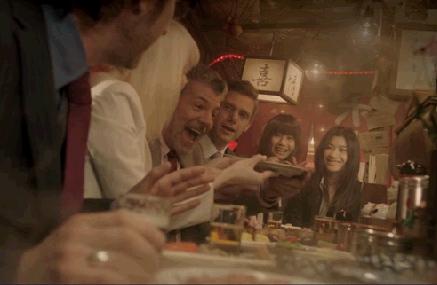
[{"xmin": 284, "ymin": 127, "xmax": 361, "ymax": 227}]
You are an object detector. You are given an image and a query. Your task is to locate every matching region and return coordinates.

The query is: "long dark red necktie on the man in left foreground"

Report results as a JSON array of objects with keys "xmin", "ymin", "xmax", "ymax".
[{"xmin": 61, "ymin": 72, "xmax": 91, "ymax": 218}]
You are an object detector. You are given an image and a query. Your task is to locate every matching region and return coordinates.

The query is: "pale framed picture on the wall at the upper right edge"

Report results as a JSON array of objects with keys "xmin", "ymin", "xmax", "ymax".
[{"xmin": 390, "ymin": 24, "xmax": 437, "ymax": 99}]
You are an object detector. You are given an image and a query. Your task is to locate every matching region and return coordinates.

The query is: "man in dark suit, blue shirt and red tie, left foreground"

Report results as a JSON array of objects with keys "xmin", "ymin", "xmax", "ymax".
[{"xmin": 0, "ymin": 0, "xmax": 213, "ymax": 283}]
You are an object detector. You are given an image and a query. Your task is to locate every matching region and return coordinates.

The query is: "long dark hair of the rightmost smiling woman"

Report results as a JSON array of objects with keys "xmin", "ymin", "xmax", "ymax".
[{"xmin": 311, "ymin": 127, "xmax": 360, "ymax": 211}]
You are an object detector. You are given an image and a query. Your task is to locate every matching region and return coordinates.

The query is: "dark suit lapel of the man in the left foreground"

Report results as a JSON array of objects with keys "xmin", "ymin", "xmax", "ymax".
[{"xmin": 11, "ymin": 0, "xmax": 61, "ymax": 195}]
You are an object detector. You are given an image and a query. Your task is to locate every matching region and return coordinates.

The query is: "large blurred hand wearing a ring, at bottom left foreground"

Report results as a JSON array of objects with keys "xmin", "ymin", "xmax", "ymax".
[{"xmin": 16, "ymin": 210, "xmax": 165, "ymax": 284}]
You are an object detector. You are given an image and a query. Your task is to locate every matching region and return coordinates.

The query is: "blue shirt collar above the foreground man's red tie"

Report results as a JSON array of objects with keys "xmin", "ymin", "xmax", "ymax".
[{"xmin": 42, "ymin": 5, "xmax": 88, "ymax": 90}]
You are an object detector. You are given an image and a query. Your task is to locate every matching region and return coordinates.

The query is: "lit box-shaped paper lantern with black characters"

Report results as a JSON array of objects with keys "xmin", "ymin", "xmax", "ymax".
[{"xmin": 241, "ymin": 57, "xmax": 303, "ymax": 104}]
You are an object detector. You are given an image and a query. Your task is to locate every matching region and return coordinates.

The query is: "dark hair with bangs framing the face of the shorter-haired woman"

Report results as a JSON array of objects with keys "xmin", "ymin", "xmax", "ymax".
[{"xmin": 258, "ymin": 114, "xmax": 300, "ymax": 162}]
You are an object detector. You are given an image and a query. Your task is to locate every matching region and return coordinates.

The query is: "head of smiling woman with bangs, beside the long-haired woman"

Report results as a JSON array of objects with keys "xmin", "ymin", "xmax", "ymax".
[{"xmin": 258, "ymin": 114, "xmax": 300, "ymax": 164}]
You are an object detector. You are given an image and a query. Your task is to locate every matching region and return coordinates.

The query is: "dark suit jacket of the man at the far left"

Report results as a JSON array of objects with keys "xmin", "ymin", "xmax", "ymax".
[{"xmin": 0, "ymin": 0, "xmax": 63, "ymax": 281}]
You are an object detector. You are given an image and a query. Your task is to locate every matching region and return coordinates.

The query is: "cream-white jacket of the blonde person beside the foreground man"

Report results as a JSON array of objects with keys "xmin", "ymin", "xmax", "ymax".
[{"xmin": 85, "ymin": 77, "xmax": 152, "ymax": 198}]
